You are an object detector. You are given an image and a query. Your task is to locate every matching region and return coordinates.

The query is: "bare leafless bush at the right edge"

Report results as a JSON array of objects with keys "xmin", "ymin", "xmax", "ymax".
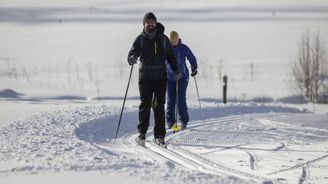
[{"xmin": 292, "ymin": 30, "xmax": 328, "ymax": 103}]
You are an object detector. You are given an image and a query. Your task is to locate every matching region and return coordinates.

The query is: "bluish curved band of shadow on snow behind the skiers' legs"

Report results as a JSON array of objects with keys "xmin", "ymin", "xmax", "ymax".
[{"xmin": 75, "ymin": 103, "xmax": 304, "ymax": 143}]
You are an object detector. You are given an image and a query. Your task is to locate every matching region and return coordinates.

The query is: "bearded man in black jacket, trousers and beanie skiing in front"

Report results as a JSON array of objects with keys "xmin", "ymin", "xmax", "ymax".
[{"xmin": 128, "ymin": 12, "xmax": 181, "ymax": 145}]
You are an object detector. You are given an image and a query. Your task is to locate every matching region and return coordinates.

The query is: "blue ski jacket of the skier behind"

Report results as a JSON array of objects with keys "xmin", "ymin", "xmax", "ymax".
[{"xmin": 166, "ymin": 39, "xmax": 198, "ymax": 81}]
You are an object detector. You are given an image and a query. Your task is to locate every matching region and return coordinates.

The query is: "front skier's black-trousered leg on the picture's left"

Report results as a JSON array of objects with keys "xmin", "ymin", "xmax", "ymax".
[{"xmin": 138, "ymin": 80, "xmax": 153, "ymax": 135}]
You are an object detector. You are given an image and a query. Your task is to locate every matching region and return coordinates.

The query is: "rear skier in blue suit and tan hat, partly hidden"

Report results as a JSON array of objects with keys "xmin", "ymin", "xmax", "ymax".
[{"xmin": 166, "ymin": 31, "xmax": 198, "ymax": 130}]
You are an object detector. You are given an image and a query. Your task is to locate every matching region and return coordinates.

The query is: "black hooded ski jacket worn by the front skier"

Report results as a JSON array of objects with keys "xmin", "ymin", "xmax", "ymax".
[{"xmin": 128, "ymin": 22, "xmax": 178, "ymax": 81}]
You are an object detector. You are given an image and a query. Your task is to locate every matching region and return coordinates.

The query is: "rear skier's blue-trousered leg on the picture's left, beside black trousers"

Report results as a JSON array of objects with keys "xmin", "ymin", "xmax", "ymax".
[{"xmin": 166, "ymin": 80, "xmax": 176, "ymax": 128}]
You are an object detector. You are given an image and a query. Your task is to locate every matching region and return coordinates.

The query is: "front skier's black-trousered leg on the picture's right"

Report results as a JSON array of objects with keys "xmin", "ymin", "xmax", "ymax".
[{"xmin": 154, "ymin": 80, "xmax": 167, "ymax": 139}]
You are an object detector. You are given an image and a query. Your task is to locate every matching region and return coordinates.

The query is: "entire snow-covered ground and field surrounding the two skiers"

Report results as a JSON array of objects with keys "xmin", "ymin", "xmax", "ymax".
[{"xmin": 0, "ymin": 0, "xmax": 328, "ymax": 184}]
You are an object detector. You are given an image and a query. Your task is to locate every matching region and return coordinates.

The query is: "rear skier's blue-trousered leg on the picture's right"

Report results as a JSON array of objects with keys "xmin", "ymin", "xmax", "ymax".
[{"xmin": 178, "ymin": 80, "xmax": 189, "ymax": 127}]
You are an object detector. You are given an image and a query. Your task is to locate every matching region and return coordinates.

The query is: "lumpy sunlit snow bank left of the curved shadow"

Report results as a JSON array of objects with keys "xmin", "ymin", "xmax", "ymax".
[{"xmin": 0, "ymin": 107, "xmax": 124, "ymax": 172}]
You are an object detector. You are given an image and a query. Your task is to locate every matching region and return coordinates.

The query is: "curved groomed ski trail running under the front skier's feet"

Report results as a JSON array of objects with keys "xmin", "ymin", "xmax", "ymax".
[{"xmin": 104, "ymin": 114, "xmax": 280, "ymax": 183}]
